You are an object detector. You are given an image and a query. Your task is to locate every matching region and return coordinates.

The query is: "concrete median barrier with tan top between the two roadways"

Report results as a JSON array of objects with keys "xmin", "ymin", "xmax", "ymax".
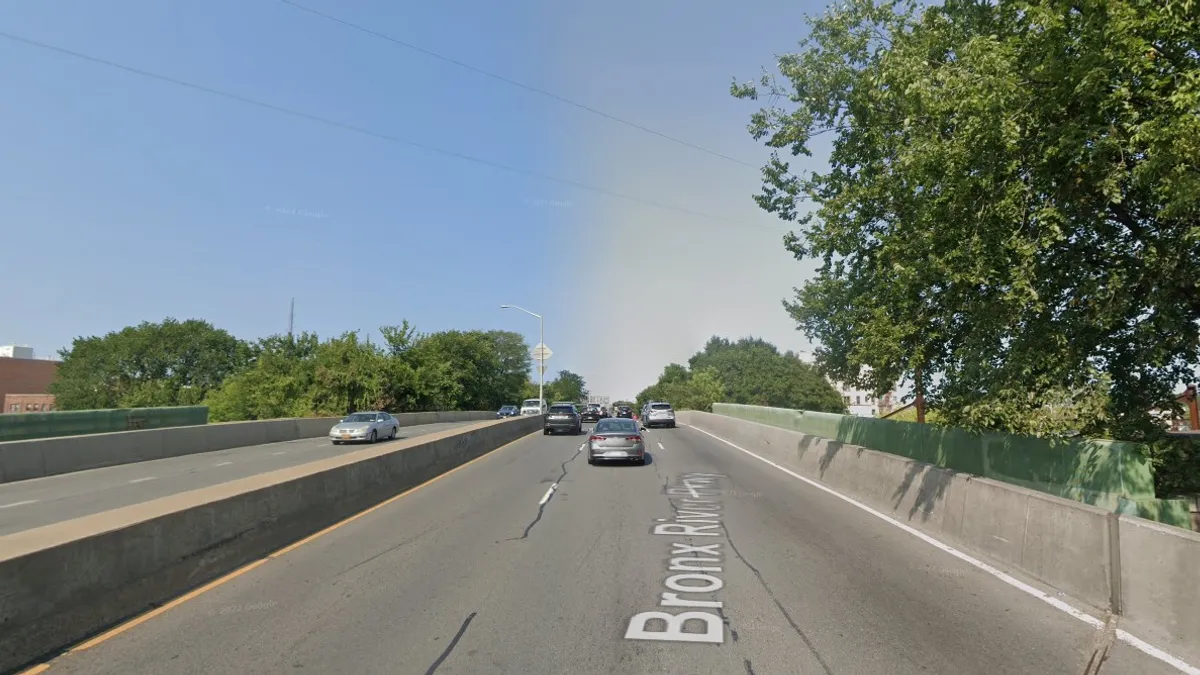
[{"xmin": 0, "ymin": 417, "xmax": 542, "ymax": 673}]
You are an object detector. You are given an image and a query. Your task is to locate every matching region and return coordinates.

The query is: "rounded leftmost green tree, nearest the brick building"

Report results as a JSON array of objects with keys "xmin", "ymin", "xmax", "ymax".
[{"xmin": 50, "ymin": 318, "xmax": 252, "ymax": 410}]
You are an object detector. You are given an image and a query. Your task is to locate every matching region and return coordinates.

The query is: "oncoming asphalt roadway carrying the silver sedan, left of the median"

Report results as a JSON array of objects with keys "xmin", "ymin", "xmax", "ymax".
[{"xmin": 0, "ymin": 422, "xmax": 478, "ymax": 536}]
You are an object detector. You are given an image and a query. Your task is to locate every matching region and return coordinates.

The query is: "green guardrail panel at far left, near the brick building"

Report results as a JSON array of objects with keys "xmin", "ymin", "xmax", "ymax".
[{"xmin": 0, "ymin": 406, "xmax": 209, "ymax": 442}]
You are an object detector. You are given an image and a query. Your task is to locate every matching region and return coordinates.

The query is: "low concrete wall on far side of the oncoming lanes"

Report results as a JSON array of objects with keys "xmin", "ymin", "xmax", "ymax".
[{"xmin": 0, "ymin": 411, "xmax": 496, "ymax": 483}]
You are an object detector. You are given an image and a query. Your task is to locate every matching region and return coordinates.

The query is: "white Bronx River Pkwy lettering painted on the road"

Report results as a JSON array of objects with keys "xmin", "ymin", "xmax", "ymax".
[{"xmin": 625, "ymin": 473, "xmax": 725, "ymax": 644}]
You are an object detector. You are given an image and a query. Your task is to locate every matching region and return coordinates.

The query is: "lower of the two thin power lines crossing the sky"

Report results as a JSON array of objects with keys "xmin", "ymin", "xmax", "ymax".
[{"xmin": 0, "ymin": 31, "xmax": 780, "ymax": 232}]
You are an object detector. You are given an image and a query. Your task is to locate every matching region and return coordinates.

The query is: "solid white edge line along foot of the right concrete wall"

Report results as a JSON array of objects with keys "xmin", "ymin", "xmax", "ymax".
[{"xmin": 688, "ymin": 424, "xmax": 1200, "ymax": 675}]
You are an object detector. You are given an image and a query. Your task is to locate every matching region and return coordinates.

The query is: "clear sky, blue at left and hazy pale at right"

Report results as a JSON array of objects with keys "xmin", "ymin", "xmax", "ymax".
[{"xmin": 0, "ymin": 0, "xmax": 821, "ymax": 398}]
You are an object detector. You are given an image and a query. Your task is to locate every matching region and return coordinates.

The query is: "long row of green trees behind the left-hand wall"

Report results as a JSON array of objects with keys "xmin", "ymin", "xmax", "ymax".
[{"xmin": 52, "ymin": 319, "xmax": 532, "ymax": 422}]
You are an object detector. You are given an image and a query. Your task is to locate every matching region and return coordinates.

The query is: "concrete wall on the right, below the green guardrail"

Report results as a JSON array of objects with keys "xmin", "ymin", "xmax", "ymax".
[{"xmin": 678, "ymin": 411, "xmax": 1200, "ymax": 658}]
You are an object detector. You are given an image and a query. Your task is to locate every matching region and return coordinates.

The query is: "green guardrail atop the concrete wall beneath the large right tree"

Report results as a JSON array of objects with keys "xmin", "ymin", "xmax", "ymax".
[{"xmin": 713, "ymin": 404, "xmax": 1192, "ymax": 530}]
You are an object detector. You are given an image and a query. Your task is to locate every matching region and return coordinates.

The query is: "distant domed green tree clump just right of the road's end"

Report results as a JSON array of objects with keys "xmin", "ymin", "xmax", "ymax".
[{"xmin": 637, "ymin": 335, "xmax": 846, "ymax": 413}]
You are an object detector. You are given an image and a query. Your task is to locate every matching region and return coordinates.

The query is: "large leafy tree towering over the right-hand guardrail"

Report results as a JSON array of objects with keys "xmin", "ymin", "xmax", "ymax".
[{"xmin": 732, "ymin": 0, "xmax": 1200, "ymax": 437}]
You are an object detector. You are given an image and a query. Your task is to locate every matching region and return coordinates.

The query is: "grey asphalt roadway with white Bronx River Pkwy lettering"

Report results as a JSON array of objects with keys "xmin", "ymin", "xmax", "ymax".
[{"xmin": 35, "ymin": 428, "xmax": 1175, "ymax": 675}]
